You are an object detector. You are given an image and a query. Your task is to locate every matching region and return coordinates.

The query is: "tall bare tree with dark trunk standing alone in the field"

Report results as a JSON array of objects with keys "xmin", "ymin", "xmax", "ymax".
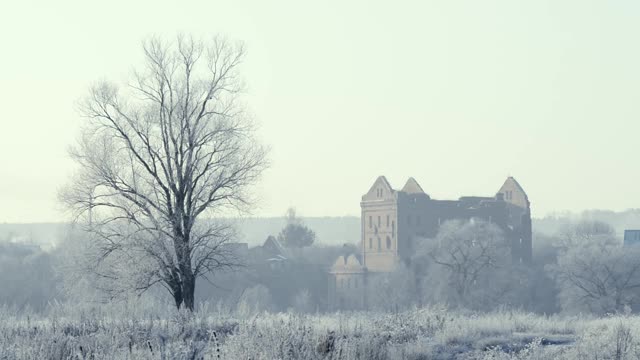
[{"xmin": 61, "ymin": 36, "xmax": 267, "ymax": 310}]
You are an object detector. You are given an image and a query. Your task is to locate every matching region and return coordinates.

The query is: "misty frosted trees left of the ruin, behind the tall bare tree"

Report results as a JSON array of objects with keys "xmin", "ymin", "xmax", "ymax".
[{"xmin": 0, "ymin": 219, "xmax": 357, "ymax": 312}]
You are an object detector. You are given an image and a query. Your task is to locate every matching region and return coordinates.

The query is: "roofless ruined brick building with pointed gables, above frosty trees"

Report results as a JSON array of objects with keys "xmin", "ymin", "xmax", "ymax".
[{"xmin": 329, "ymin": 176, "xmax": 532, "ymax": 309}]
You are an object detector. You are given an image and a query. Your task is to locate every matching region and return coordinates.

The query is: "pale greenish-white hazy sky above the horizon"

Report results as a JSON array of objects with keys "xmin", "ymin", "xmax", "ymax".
[{"xmin": 0, "ymin": 0, "xmax": 640, "ymax": 222}]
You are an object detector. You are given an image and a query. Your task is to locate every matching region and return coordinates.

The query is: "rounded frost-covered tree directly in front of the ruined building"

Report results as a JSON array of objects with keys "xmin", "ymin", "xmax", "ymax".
[{"xmin": 413, "ymin": 220, "xmax": 526, "ymax": 309}]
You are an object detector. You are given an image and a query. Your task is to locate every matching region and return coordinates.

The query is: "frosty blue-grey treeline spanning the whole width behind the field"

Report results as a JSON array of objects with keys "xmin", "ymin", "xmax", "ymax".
[{"xmin": 0, "ymin": 211, "xmax": 640, "ymax": 314}]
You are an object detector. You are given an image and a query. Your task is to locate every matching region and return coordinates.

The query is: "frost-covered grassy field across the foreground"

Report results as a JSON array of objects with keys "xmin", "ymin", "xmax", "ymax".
[{"xmin": 0, "ymin": 304, "xmax": 640, "ymax": 360}]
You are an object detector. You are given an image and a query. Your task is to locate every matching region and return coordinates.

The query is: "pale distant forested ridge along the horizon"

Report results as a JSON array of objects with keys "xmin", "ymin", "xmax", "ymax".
[{"xmin": 0, "ymin": 209, "xmax": 640, "ymax": 249}]
